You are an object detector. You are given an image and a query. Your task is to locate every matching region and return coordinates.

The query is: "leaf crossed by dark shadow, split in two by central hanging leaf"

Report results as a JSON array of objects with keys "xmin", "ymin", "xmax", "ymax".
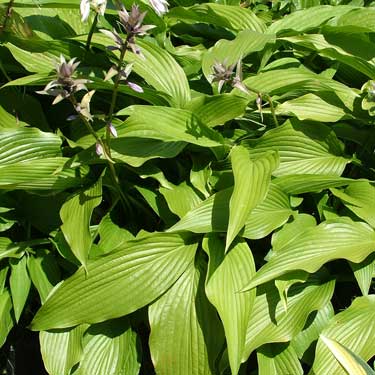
[{"xmin": 168, "ymin": 183, "xmax": 293, "ymax": 239}]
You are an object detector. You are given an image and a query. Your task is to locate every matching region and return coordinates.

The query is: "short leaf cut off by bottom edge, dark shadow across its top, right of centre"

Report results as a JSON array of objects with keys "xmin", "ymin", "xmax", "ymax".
[{"xmin": 257, "ymin": 344, "xmax": 303, "ymax": 375}]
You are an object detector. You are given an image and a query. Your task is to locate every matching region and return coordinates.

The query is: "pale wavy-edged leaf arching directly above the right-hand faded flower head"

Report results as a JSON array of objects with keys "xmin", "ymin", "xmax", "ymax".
[{"xmin": 202, "ymin": 29, "xmax": 275, "ymax": 81}]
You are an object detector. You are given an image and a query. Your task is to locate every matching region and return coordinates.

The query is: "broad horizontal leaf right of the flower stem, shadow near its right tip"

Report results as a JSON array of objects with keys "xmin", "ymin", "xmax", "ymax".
[{"xmin": 117, "ymin": 105, "xmax": 223, "ymax": 147}]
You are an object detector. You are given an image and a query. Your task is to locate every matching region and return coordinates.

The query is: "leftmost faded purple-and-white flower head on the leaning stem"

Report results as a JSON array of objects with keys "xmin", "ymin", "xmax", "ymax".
[{"xmin": 37, "ymin": 55, "xmax": 90, "ymax": 104}]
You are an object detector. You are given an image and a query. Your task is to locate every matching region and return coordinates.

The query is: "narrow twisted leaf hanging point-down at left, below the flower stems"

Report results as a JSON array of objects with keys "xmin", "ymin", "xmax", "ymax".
[{"xmin": 60, "ymin": 178, "xmax": 102, "ymax": 268}]
